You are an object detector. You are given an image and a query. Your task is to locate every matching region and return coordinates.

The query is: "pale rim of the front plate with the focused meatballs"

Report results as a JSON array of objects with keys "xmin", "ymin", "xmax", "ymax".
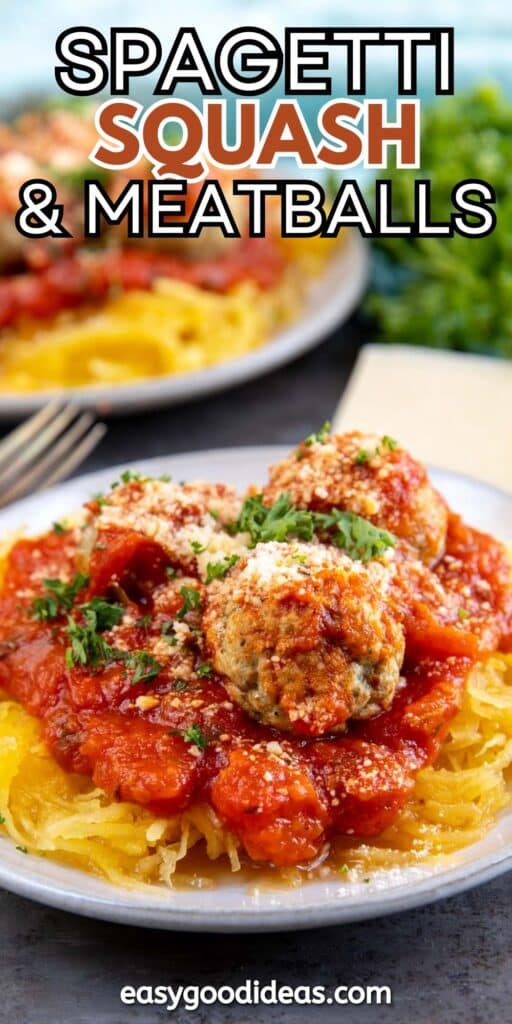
[{"xmin": 0, "ymin": 444, "xmax": 512, "ymax": 933}]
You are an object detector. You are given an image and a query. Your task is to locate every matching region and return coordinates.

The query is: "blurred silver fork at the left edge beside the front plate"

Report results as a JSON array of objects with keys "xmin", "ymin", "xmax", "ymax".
[{"xmin": 0, "ymin": 398, "xmax": 106, "ymax": 508}]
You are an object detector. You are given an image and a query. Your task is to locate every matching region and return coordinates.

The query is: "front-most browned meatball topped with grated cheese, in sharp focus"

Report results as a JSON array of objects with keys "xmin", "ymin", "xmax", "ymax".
[{"xmin": 203, "ymin": 542, "xmax": 404, "ymax": 736}]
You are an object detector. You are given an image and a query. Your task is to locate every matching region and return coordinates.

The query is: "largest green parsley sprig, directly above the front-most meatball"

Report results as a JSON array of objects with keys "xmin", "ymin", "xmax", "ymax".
[{"xmin": 228, "ymin": 493, "xmax": 314, "ymax": 545}]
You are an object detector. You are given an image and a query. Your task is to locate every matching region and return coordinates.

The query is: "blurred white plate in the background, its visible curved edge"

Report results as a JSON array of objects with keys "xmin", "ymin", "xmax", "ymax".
[{"xmin": 0, "ymin": 230, "xmax": 369, "ymax": 420}]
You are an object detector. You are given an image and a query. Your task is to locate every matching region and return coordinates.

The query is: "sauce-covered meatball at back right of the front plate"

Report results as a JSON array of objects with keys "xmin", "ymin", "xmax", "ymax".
[{"xmin": 263, "ymin": 431, "xmax": 447, "ymax": 565}]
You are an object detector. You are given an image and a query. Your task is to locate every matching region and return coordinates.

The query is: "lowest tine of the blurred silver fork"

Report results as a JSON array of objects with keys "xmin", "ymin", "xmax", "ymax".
[{"xmin": 0, "ymin": 413, "xmax": 106, "ymax": 507}]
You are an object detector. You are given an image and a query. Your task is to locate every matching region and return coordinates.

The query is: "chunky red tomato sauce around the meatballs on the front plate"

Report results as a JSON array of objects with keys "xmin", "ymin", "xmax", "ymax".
[{"xmin": 0, "ymin": 517, "xmax": 511, "ymax": 865}]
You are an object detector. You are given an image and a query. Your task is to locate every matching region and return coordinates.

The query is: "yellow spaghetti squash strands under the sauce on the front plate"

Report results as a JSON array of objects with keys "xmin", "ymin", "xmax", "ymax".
[{"xmin": 0, "ymin": 654, "xmax": 512, "ymax": 886}]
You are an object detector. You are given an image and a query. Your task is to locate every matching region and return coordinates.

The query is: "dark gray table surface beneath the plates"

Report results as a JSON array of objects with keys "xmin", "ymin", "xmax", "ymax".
[{"xmin": 0, "ymin": 321, "xmax": 512, "ymax": 1024}]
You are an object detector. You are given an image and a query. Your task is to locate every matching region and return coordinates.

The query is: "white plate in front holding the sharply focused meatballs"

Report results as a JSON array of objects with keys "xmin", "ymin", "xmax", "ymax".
[{"xmin": 0, "ymin": 447, "xmax": 512, "ymax": 932}]
